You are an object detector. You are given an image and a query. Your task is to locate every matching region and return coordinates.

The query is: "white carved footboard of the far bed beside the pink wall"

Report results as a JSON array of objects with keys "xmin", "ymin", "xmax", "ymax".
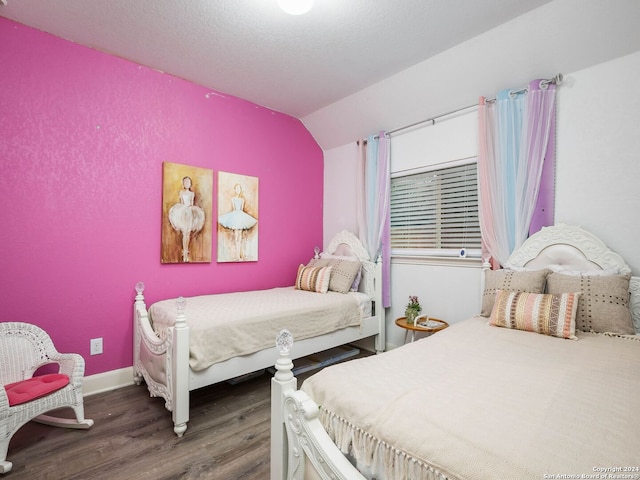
[{"xmin": 133, "ymin": 282, "xmax": 189, "ymax": 437}]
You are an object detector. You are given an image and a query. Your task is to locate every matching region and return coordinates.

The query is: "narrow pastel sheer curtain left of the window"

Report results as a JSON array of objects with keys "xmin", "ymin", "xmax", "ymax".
[{"xmin": 357, "ymin": 132, "xmax": 391, "ymax": 308}]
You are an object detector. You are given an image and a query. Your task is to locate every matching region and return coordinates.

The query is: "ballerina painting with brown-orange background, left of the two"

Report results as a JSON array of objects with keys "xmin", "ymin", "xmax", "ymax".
[{"xmin": 161, "ymin": 162, "xmax": 213, "ymax": 263}]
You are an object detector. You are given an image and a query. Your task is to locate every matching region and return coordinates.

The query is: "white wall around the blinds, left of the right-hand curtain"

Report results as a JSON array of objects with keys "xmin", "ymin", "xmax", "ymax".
[{"xmin": 324, "ymin": 109, "xmax": 480, "ymax": 348}]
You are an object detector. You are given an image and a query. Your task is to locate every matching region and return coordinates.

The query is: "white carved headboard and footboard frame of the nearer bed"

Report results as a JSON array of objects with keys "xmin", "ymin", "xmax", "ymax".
[{"xmin": 271, "ymin": 224, "xmax": 640, "ymax": 480}]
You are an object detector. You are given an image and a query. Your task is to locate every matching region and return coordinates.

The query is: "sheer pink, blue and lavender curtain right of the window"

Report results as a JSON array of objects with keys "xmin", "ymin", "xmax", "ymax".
[{"xmin": 478, "ymin": 80, "xmax": 555, "ymax": 265}]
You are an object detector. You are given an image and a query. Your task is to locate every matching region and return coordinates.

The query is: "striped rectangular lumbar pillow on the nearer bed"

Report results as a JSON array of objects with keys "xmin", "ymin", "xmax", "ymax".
[{"xmin": 489, "ymin": 290, "xmax": 580, "ymax": 340}]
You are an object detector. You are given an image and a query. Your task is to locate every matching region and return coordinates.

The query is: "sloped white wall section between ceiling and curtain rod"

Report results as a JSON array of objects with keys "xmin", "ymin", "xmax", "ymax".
[{"xmin": 302, "ymin": 0, "xmax": 640, "ymax": 151}]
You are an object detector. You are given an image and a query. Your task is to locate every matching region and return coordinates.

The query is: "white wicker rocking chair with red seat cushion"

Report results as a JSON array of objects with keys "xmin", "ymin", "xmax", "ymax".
[{"xmin": 0, "ymin": 322, "xmax": 93, "ymax": 473}]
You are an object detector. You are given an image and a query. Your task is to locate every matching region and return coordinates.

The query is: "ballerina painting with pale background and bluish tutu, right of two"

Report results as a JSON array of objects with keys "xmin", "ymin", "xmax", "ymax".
[{"xmin": 218, "ymin": 172, "xmax": 258, "ymax": 262}]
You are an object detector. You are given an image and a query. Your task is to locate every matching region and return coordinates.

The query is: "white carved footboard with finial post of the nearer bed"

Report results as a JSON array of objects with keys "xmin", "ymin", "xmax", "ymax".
[{"xmin": 271, "ymin": 330, "xmax": 365, "ymax": 480}]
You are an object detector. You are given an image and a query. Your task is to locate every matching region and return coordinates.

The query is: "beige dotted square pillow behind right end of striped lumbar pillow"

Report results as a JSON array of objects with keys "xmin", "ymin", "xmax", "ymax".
[{"xmin": 547, "ymin": 273, "xmax": 635, "ymax": 335}]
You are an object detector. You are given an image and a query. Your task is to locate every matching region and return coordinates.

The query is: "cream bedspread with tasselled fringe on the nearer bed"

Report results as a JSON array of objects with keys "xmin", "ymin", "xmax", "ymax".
[{"xmin": 302, "ymin": 318, "xmax": 640, "ymax": 480}]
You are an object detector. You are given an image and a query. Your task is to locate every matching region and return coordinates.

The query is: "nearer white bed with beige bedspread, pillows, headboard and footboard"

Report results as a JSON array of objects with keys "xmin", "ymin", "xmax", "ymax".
[{"xmin": 271, "ymin": 224, "xmax": 640, "ymax": 480}]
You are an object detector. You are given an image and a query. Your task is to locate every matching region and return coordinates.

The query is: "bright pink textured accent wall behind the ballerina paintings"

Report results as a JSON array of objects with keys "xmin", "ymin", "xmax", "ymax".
[{"xmin": 0, "ymin": 18, "xmax": 323, "ymax": 375}]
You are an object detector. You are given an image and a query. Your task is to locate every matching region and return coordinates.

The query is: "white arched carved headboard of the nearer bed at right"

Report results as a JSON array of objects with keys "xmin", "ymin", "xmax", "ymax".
[{"xmin": 505, "ymin": 223, "xmax": 640, "ymax": 332}]
